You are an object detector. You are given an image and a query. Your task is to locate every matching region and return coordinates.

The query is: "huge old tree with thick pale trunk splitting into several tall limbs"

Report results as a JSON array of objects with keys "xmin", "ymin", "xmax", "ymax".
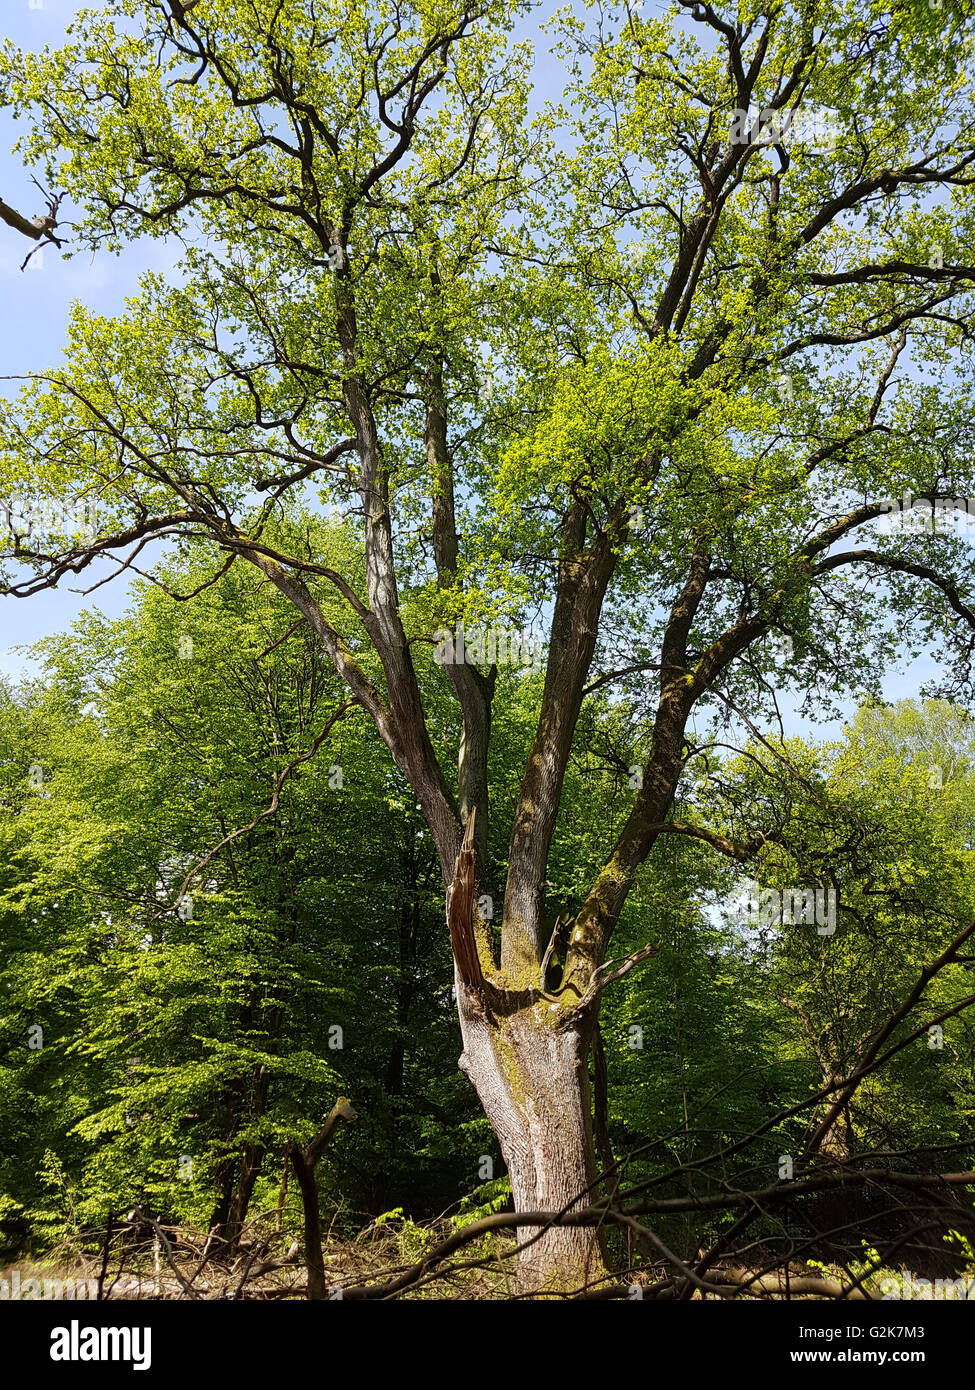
[{"xmin": 0, "ymin": 0, "xmax": 975, "ymax": 1291}]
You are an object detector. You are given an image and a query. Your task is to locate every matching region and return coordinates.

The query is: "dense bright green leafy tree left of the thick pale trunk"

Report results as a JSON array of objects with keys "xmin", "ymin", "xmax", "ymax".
[{"xmin": 0, "ymin": 544, "xmax": 483, "ymax": 1248}]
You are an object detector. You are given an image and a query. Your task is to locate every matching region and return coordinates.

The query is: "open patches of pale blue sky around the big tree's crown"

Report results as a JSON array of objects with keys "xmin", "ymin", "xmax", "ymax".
[{"xmin": 0, "ymin": 0, "xmax": 933, "ymax": 735}]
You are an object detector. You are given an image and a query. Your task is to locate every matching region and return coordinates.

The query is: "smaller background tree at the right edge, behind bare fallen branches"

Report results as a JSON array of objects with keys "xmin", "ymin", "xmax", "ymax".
[{"xmin": 715, "ymin": 701, "xmax": 975, "ymax": 1161}]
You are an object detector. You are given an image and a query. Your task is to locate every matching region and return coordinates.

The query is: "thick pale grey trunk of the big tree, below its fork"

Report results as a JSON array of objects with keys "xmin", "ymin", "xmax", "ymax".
[{"xmin": 458, "ymin": 979, "xmax": 606, "ymax": 1294}]
